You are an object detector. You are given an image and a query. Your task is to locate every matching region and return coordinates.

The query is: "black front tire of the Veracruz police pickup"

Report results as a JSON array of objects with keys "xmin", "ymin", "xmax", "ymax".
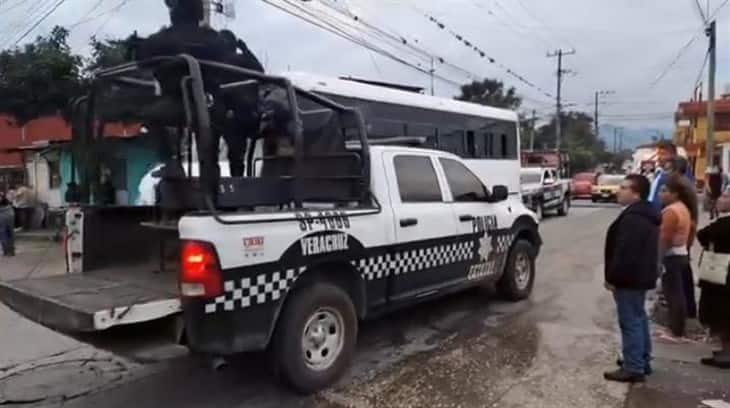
[{"xmin": 497, "ymin": 239, "xmax": 535, "ymax": 302}]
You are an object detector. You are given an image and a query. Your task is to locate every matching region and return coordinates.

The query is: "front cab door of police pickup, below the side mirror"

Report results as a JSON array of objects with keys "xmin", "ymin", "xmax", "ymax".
[{"xmin": 439, "ymin": 157, "xmax": 510, "ymax": 283}]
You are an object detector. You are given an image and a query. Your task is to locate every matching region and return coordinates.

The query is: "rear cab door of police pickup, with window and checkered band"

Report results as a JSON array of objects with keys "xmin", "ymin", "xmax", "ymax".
[{"xmin": 383, "ymin": 152, "xmax": 456, "ymax": 302}]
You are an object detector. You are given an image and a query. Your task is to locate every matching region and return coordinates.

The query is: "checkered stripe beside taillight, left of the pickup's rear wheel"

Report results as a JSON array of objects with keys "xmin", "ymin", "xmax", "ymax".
[{"xmin": 205, "ymin": 267, "xmax": 307, "ymax": 313}]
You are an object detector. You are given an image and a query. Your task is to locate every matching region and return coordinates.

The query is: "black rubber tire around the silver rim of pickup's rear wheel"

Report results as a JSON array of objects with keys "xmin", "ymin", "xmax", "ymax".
[{"xmin": 272, "ymin": 283, "xmax": 358, "ymax": 395}]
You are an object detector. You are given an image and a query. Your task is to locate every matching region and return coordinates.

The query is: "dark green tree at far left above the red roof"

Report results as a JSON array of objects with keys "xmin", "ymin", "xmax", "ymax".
[{"xmin": 0, "ymin": 26, "xmax": 83, "ymax": 125}]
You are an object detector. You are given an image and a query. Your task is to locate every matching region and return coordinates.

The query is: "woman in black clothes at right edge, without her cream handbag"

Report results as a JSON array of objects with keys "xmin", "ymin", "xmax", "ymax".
[{"xmin": 697, "ymin": 194, "xmax": 730, "ymax": 369}]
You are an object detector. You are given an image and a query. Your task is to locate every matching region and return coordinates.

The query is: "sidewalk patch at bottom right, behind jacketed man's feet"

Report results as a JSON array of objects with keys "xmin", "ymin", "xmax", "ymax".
[{"xmin": 626, "ymin": 331, "xmax": 730, "ymax": 408}]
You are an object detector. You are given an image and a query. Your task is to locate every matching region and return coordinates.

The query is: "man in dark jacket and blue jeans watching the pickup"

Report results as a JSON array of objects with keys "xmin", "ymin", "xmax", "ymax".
[{"xmin": 604, "ymin": 174, "xmax": 661, "ymax": 382}]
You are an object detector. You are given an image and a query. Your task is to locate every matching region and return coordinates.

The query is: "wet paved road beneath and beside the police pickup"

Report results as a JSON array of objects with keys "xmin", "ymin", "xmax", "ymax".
[{"xmin": 0, "ymin": 203, "xmax": 627, "ymax": 408}]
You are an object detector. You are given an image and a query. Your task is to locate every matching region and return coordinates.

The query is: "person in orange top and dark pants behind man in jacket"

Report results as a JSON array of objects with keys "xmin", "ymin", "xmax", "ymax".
[{"xmin": 659, "ymin": 176, "xmax": 694, "ymax": 337}]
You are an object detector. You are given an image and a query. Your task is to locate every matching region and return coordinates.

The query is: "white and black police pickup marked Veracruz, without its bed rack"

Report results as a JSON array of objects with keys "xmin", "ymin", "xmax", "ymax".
[{"xmin": 179, "ymin": 146, "xmax": 541, "ymax": 393}]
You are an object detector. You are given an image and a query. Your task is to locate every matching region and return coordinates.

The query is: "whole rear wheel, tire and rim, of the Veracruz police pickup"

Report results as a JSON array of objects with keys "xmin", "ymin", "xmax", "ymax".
[{"xmin": 273, "ymin": 283, "xmax": 357, "ymax": 394}]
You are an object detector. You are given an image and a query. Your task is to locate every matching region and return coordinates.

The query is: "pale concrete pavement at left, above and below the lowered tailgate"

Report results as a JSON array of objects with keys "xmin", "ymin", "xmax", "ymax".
[{"xmin": 0, "ymin": 241, "xmax": 139, "ymax": 406}]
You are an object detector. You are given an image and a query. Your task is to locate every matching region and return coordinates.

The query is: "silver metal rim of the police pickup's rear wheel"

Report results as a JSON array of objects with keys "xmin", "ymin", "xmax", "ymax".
[{"xmin": 302, "ymin": 308, "xmax": 345, "ymax": 371}]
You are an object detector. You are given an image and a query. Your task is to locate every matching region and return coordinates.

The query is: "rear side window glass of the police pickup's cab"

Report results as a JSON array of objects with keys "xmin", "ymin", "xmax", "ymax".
[{"xmin": 393, "ymin": 155, "xmax": 443, "ymax": 203}]
